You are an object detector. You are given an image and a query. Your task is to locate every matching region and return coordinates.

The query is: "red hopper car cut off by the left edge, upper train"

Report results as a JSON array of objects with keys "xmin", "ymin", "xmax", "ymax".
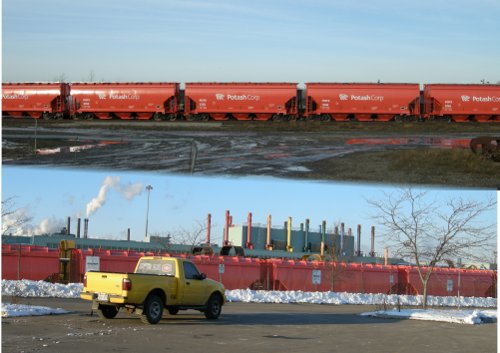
[{"xmin": 2, "ymin": 82, "xmax": 69, "ymax": 119}]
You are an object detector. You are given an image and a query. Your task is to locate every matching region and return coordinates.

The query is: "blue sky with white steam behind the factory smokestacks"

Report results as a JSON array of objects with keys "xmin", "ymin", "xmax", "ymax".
[{"xmin": 2, "ymin": 166, "xmax": 496, "ymax": 252}]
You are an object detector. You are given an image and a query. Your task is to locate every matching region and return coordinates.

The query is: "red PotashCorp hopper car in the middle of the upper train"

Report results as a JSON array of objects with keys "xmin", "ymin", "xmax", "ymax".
[{"xmin": 184, "ymin": 83, "xmax": 298, "ymax": 120}]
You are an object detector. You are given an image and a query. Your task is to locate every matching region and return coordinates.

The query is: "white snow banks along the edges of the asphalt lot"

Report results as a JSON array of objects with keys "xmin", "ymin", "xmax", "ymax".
[{"xmin": 1, "ymin": 280, "xmax": 497, "ymax": 324}]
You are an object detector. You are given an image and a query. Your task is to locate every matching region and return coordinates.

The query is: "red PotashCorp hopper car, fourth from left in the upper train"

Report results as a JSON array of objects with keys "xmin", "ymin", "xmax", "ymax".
[{"xmin": 304, "ymin": 83, "xmax": 420, "ymax": 121}]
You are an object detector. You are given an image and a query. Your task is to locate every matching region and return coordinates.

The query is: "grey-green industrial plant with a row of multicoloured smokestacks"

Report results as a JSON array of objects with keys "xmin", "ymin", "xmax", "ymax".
[{"xmin": 2, "ymin": 211, "xmax": 402, "ymax": 263}]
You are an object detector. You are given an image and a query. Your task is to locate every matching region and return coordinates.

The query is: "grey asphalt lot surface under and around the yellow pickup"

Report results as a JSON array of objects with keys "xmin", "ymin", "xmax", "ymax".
[{"xmin": 2, "ymin": 298, "xmax": 497, "ymax": 353}]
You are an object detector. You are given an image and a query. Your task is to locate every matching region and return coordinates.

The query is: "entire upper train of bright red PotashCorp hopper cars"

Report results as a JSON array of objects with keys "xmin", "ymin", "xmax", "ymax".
[{"xmin": 2, "ymin": 82, "xmax": 500, "ymax": 123}]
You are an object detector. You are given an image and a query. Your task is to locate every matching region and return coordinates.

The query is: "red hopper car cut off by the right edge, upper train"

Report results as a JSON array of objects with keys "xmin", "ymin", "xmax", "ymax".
[{"xmin": 424, "ymin": 84, "xmax": 500, "ymax": 122}]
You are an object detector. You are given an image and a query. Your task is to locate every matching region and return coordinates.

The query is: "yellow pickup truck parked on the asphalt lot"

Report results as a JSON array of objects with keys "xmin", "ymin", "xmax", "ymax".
[{"xmin": 80, "ymin": 256, "xmax": 226, "ymax": 324}]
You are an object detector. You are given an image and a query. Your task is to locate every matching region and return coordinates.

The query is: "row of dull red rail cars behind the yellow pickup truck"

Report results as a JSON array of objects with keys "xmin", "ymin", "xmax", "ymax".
[{"xmin": 2, "ymin": 245, "xmax": 497, "ymax": 297}]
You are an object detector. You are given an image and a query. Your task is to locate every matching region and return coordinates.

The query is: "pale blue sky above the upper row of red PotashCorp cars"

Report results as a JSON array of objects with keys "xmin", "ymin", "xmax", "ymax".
[{"xmin": 2, "ymin": 0, "xmax": 500, "ymax": 83}]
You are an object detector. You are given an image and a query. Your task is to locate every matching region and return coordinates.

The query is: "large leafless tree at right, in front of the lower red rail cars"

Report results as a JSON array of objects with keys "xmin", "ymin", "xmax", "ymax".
[{"xmin": 368, "ymin": 188, "xmax": 496, "ymax": 309}]
